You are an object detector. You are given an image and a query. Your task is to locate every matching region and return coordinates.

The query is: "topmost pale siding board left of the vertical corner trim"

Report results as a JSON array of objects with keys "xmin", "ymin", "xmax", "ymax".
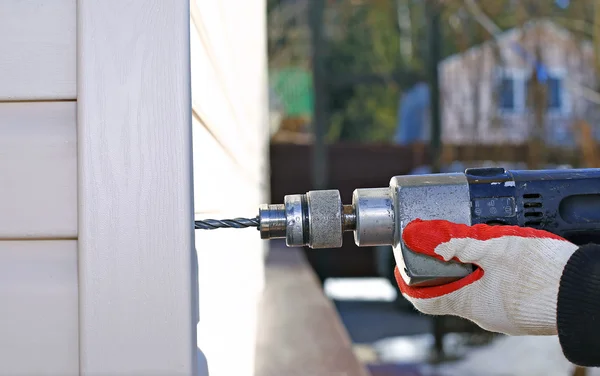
[{"xmin": 0, "ymin": 0, "xmax": 77, "ymax": 101}]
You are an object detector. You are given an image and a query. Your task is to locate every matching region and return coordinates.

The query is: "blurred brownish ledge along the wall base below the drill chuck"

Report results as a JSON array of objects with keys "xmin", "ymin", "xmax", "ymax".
[{"xmin": 255, "ymin": 245, "xmax": 368, "ymax": 376}]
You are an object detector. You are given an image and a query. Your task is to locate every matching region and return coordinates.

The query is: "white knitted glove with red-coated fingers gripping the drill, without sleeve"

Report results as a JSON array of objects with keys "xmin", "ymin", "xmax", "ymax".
[{"xmin": 395, "ymin": 220, "xmax": 577, "ymax": 335}]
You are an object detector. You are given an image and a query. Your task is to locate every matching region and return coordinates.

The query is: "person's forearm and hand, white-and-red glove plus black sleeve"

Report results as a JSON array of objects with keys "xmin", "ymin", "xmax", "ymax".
[{"xmin": 396, "ymin": 220, "xmax": 600, "ymax": 366}]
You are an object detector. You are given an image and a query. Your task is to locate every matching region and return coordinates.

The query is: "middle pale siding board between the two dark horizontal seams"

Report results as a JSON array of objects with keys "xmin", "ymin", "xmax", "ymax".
[{"xmin": 0, "ymin": 102, "xmax": 77, "ymax": 239}]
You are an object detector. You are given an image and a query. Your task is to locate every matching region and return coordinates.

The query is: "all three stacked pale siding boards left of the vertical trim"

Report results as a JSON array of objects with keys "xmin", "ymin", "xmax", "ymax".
[{"xmin": 0, "ymin": 0, "xmax": 79, "ymax": 376}]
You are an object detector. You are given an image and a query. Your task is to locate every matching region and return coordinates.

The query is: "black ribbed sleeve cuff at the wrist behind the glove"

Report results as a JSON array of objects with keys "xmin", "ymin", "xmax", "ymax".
[{"xmin": 556, "ymin": 244, "xmax": 600, "ymax": 367}]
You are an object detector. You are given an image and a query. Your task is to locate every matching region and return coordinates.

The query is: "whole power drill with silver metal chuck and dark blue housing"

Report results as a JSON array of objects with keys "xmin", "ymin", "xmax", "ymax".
[{"xmin": 197, "ymin": 167, "xmax": 600, "ymax": 286}]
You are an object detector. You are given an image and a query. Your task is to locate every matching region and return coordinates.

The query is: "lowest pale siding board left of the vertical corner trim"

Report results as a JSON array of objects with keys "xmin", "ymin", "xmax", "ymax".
[{"xmin": 0, "ymin": 240, "xmax": 79, "ymax": 376}]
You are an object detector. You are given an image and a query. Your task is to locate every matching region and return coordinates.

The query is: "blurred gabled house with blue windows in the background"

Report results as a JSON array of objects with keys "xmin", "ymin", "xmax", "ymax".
[{"xmin": 439, "ymin": 21, "xmax": 599, "ymax": 147}]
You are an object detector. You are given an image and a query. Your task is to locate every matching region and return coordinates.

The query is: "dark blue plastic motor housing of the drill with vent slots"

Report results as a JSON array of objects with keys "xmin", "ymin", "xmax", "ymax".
[{"xmin": 465, "ymin": 168, "xmax": 600, "ymax": 245}]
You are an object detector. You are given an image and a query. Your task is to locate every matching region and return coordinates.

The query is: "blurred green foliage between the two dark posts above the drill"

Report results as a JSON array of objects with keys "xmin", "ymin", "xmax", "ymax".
[{"xmin": 327, "ymin": 0, "xmax": 408, "ymax": 141}]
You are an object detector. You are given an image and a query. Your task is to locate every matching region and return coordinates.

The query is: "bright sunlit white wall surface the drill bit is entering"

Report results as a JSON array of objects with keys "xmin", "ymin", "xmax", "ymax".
[{"xmin": 191, "ymin": 0, "xmax": 269, "ymax": 376}]
